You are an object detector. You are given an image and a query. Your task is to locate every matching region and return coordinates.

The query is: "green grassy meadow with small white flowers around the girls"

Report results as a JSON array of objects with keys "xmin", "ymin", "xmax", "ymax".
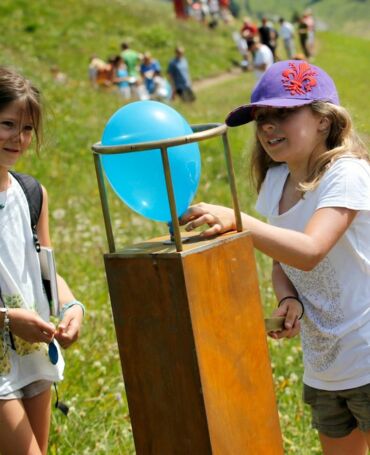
[{"xmin": 0, "ymin": 0, "xmax": 370, "ymax": 455}]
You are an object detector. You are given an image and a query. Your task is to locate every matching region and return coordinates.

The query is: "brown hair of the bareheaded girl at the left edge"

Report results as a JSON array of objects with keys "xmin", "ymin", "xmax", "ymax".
[{"xmin": 0, "ymin": 66, "xmax": 42, "ymax": 151}]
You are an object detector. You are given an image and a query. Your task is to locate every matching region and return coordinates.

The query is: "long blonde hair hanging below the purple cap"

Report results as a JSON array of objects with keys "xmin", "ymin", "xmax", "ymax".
[{"xmin": 251, "ymin": 101, "xmax": 370, "ymax": 193}]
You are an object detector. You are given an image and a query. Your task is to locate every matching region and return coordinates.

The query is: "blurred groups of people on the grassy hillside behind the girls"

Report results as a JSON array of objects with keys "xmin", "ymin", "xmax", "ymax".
[{"xmin": 89, "ymin": 6, "xmax": 315, "ymax": 103}]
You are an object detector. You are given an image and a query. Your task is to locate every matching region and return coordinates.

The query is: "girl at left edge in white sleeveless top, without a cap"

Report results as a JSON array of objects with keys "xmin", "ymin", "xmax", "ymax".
[{"xmin": 0, "ymin": 67, "xmax": 84, "ymax": 455}]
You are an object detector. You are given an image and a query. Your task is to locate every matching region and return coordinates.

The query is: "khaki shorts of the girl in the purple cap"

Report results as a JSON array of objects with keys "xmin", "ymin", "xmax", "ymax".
[{"xmin": 303, "ymin": 384, "xmax": 370, "ymax": 438}]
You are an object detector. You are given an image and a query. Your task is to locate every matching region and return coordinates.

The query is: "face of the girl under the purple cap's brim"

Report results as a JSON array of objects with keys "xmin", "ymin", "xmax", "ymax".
[{"xmin": 254, "ymin": 106, "xmax": 325, "ymax": 165}]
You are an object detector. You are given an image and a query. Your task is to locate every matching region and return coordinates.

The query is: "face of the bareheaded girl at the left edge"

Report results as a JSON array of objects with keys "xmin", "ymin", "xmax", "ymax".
[{"xmin": 0, "ymin": 101, "xmax": 33, "ymax": 169}]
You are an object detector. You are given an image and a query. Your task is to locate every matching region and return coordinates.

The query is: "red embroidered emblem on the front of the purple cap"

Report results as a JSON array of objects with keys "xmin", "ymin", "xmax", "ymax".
[{"xmin": 281, "ymin": 62, "xmax": 317, "ymax": 96}]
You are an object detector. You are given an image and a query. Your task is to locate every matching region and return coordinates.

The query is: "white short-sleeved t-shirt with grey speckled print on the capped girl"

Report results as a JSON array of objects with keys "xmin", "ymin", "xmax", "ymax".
[{"xmin": 256, "ymin": 157, "xmax": 370, "ymax": 390}]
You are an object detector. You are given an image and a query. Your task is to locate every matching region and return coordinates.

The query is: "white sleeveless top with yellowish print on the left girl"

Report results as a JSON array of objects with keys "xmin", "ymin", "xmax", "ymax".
[{"xmin": 0, "ymin": 174, "xmax": 64, "ymax": 395}]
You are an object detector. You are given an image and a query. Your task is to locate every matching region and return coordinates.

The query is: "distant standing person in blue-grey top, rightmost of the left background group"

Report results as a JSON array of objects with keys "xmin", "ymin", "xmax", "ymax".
[{"xmin": 167, "ymin": 46, "xmax": 195, "ymax": 102}]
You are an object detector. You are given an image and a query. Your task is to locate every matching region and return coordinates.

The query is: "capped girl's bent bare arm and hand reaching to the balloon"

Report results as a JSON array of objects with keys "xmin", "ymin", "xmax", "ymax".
[{"xmin": 181, "ymin": 203, "xmax": 357, "ymax": 271}]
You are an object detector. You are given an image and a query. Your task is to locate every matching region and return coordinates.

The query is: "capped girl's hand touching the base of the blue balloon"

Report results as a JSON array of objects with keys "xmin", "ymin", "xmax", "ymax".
[{"xmin": 180, "ymin": 202, "xmax": 235, "ymax": 237}]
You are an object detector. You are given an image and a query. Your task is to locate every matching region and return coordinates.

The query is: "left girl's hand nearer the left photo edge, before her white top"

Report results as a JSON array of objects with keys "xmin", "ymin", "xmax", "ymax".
[{"xmin": 8, "ymin": 308, "xmax": 55, "ymax": 343}]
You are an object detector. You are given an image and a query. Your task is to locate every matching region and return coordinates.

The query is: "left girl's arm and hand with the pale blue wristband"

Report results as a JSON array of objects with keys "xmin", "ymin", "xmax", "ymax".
[{"xmin": 37, "ymin": 187, "xmax": 83, "ymax": 348}]
